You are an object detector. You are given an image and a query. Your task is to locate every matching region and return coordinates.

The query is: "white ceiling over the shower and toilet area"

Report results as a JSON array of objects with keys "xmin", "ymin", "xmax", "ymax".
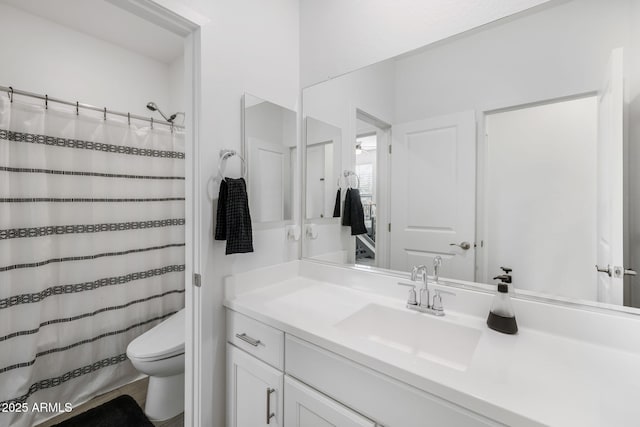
[{"xmin": 1, "ymin": 0, "xmax": 183, "ymax": 64}]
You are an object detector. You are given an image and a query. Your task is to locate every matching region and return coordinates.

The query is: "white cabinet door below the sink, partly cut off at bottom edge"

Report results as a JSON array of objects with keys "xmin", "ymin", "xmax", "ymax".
[{"xmin": 284, "ymin": 376, "xmax": 376, "ymax": 427}]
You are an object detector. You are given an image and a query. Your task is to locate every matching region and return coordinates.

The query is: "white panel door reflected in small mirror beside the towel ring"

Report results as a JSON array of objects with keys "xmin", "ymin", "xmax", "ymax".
[{"xmin": 248, "ymin": 137, "xmax": 289, "ymax": 222}]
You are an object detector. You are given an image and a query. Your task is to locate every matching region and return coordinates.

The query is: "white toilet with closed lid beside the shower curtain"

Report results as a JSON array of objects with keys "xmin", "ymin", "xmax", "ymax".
[{"xmin": 127, "ymin": 309, "xmax": 185, "ymax": 421}]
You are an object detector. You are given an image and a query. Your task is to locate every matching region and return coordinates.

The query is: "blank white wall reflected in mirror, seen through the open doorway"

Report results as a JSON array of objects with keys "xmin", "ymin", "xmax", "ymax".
[{"xmin": 484, "ymin": 96, "xmax": 598, "ymax": 301}]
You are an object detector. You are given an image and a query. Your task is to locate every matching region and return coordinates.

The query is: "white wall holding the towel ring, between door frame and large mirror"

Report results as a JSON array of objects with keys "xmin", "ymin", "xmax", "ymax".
[{"xmin": 170, "ymin": 0, "xmax": 300, "ymax": 427}]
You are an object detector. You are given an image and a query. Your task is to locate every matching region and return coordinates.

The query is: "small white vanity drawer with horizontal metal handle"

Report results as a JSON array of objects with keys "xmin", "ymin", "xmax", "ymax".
[{"xmin": 227, "ymin": 310, "xmax": 284, "ymax": 370}]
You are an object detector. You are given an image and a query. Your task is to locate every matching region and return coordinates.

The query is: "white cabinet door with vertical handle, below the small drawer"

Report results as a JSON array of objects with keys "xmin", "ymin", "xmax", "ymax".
[{"xmin": 227, "ymin": 344, "xmax": 284, "ymax": 427}]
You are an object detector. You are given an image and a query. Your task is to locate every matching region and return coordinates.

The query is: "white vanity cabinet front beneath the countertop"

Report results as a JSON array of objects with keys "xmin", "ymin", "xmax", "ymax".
[{"xmin": 227, "ymin": 310, "xmax": 503, "ymax": 427}]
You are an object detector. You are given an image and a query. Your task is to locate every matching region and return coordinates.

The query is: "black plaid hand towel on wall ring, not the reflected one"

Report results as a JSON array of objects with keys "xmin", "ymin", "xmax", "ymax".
[{"xmin": 215, "ymin": 178, "xmax": 253, "ymax": 255}]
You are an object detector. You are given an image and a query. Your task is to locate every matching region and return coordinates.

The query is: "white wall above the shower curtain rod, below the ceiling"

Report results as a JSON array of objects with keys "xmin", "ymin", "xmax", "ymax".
[{"xmin": 0, "ymin": 3, "xmax": 171, "ymax": 118}]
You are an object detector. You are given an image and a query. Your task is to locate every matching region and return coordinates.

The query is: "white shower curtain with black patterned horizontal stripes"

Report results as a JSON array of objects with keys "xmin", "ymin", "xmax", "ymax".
[{"xmin": 0, "ymin": 94, "xmax": 185, "ymax": 427}]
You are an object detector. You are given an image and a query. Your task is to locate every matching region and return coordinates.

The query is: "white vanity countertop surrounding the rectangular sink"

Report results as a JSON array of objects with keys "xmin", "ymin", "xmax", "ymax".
[{"xmin": 225, "ymin": 260, "xmax": 640, "ymax": 427}]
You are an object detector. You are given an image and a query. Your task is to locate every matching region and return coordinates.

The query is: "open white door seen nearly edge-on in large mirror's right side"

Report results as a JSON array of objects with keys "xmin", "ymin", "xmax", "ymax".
[{"xmin": 597, "ymin": 48, "xmax": 624, "ymax": 305}]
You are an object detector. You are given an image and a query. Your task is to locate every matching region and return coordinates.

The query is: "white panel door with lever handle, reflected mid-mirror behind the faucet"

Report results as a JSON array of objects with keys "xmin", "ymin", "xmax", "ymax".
[{"xmin": 390, "ymin": 111, "xmax": 476, "ymax": 280}]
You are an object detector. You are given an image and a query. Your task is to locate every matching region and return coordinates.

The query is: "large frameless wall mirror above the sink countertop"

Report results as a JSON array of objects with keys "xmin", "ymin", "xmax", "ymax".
[{"xmin": 303, "ymin": 0, "xmax": 640, "ymax": 311}]
